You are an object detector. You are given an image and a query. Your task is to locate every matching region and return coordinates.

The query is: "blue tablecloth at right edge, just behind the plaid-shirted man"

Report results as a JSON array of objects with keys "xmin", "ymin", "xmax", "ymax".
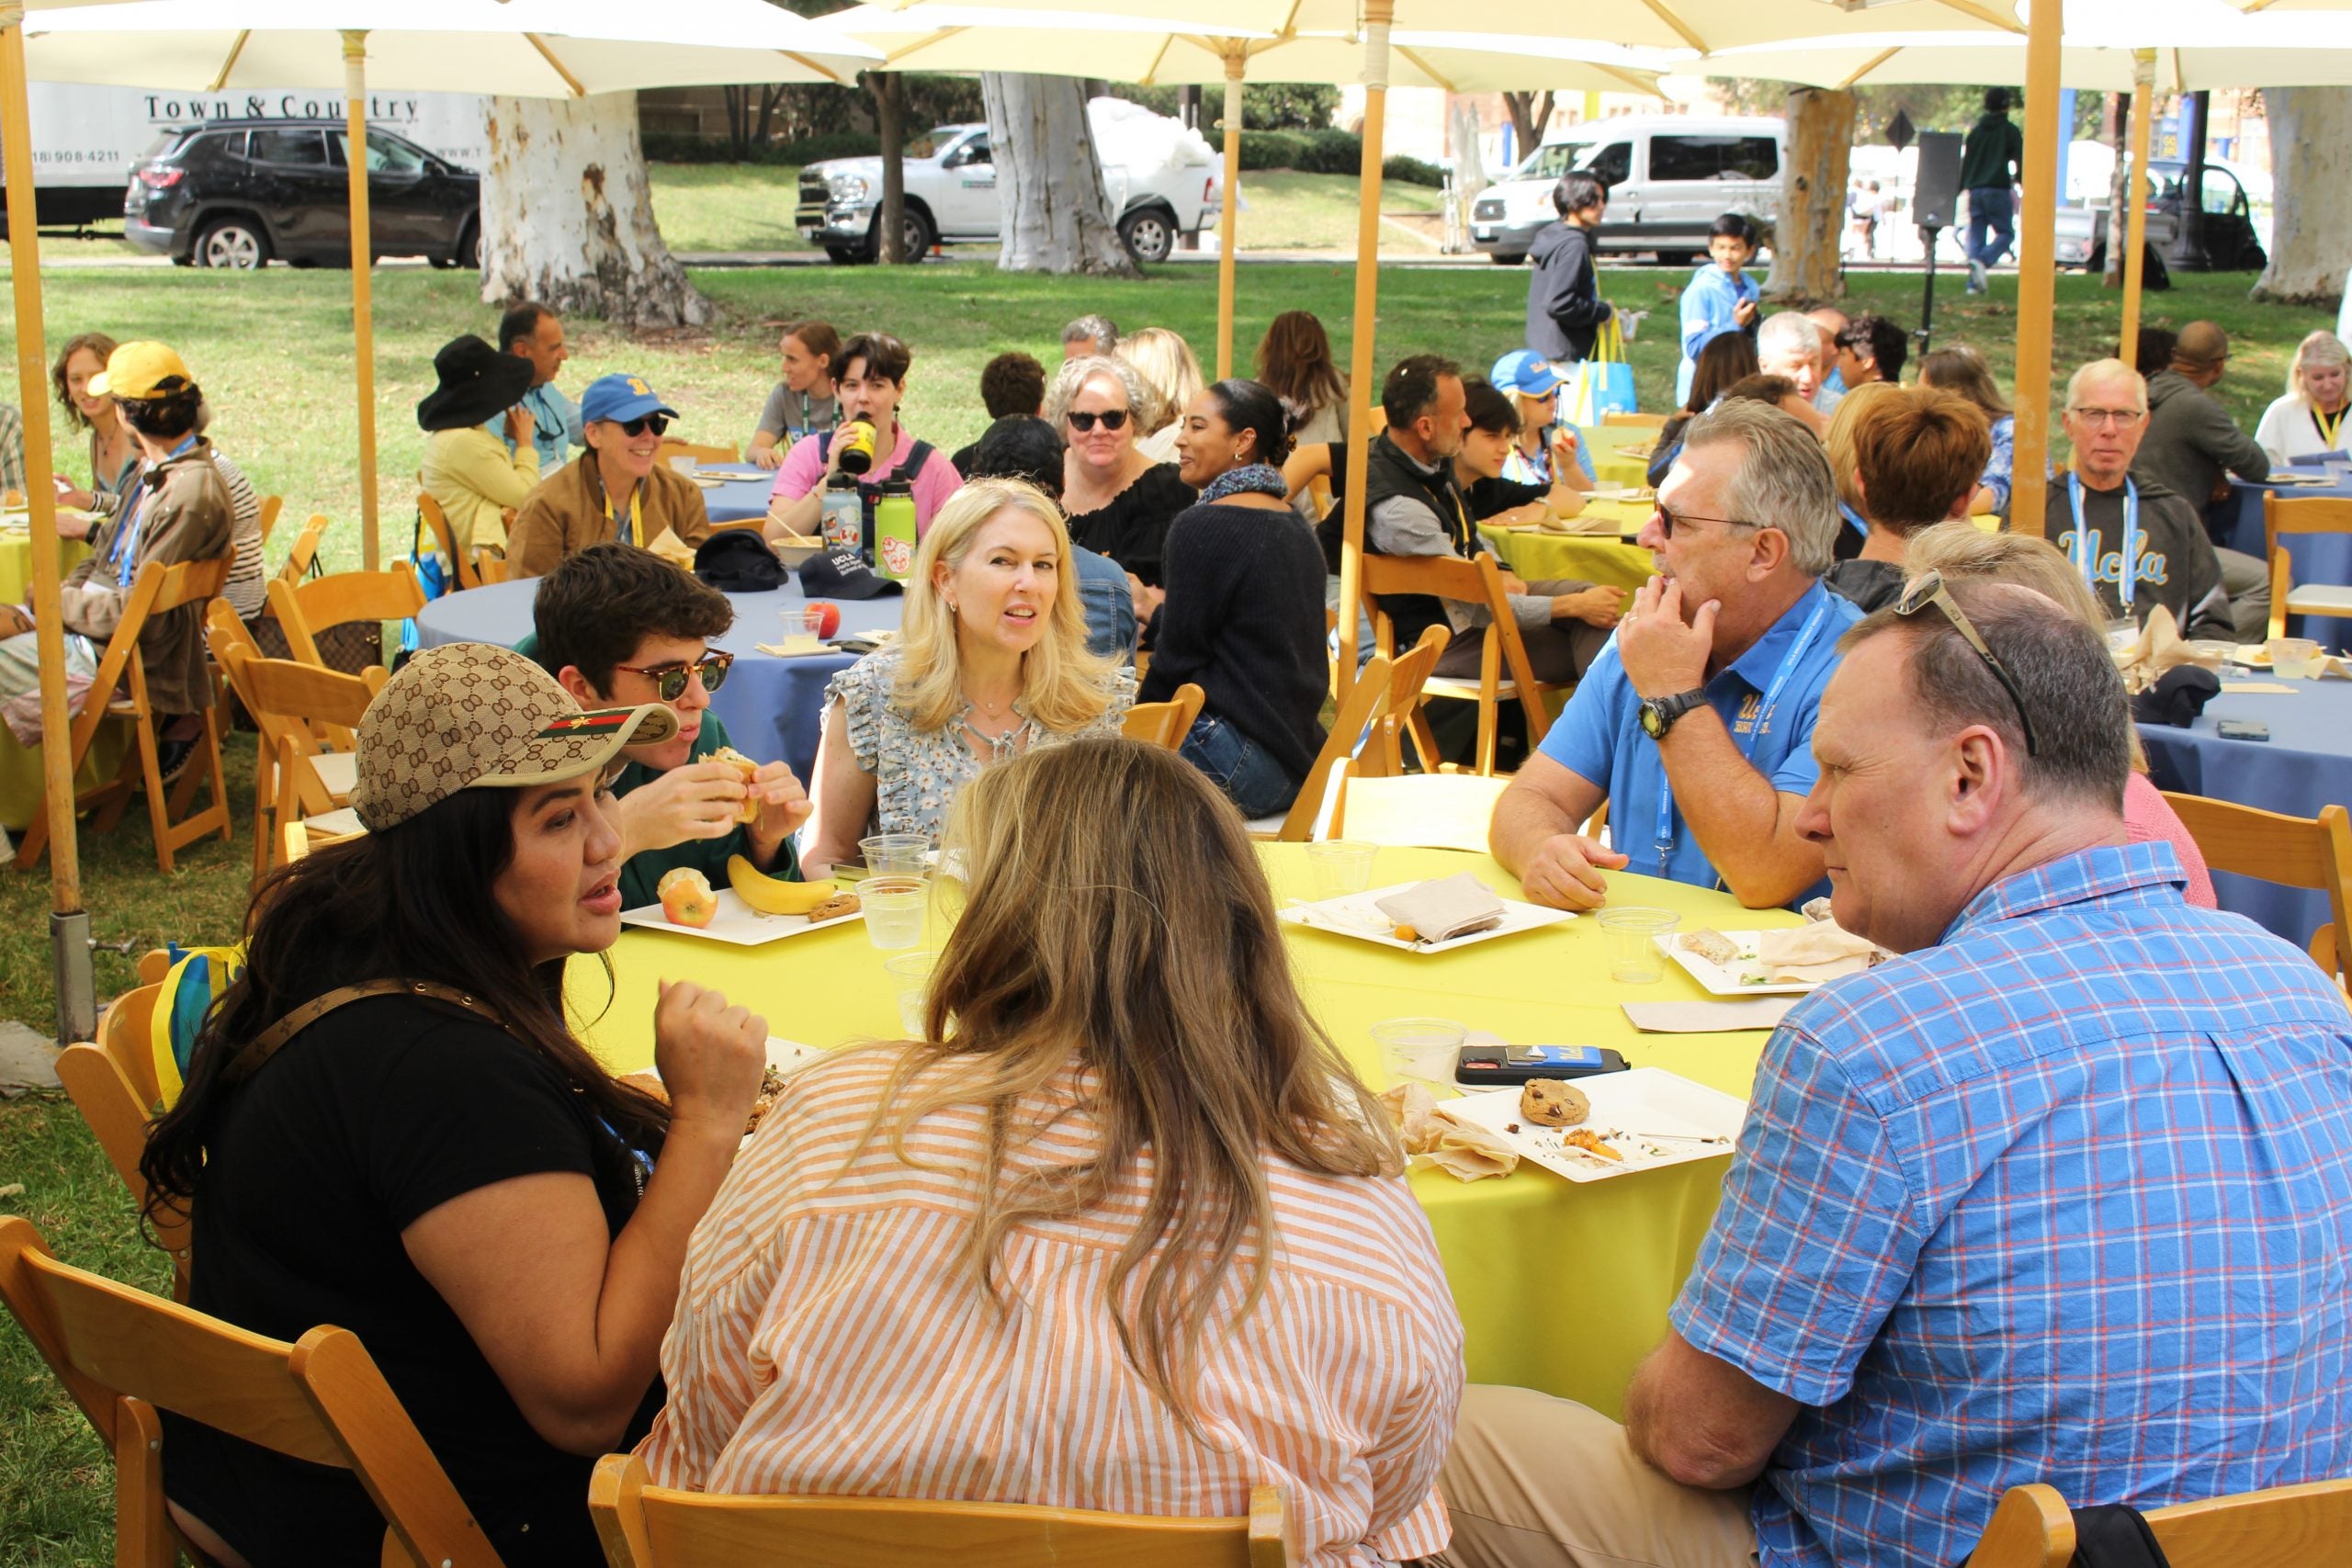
[{"xmin": 2141, "ymin": 670, "xmax": 2352, "ymax": 947}]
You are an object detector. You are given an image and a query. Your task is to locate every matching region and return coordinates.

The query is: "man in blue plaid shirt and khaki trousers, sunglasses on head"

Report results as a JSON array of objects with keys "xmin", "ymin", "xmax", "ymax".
[{"xmin": 1442, "ymin": 576, "xmax": 2352, "ymax": 1568}]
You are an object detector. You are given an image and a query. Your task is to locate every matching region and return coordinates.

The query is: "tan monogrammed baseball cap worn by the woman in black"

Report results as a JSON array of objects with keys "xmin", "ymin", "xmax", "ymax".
[{"xmin": 350, "ymin": 642, "xmax": 677, "ymax": 832}]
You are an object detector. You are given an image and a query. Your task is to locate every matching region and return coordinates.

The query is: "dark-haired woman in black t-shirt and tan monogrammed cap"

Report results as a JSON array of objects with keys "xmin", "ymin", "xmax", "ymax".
[{"xmin": 141, "ymin": 644, "xmax": 767, "ymax": 1568}]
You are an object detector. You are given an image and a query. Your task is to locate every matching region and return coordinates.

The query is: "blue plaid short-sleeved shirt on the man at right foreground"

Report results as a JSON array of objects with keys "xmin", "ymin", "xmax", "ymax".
[{"xmin": 1672, "ymin": 844, "xmax": 2352, "ymax": 1568}]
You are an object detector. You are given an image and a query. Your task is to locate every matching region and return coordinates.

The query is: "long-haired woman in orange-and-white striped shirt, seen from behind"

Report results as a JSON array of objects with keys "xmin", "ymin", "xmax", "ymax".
[{"xmin": 642, "ymin": 740, "xmax": 1463, "ymax": 1565}]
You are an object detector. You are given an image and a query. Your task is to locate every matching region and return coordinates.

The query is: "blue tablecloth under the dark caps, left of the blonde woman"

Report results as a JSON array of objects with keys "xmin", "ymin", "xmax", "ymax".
[{"xmin": 416, "ymin": 579, "xmax": 903, "ymax": 783}]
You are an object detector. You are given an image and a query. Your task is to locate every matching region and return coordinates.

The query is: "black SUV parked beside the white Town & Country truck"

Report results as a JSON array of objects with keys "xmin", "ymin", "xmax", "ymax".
[{"xmin": 122, "ymin": 120, "xmax": 482, "ymax": 268}]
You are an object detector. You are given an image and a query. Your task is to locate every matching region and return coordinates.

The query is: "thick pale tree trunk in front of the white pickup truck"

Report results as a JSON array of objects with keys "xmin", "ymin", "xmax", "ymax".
[{"xmin": 981, "ymin": 71, "xmax": 1138, "ymax": 277}]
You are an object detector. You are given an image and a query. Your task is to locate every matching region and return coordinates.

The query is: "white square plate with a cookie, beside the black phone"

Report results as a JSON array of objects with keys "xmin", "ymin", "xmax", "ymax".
[{"xmin": 1440, "ymin": 1067, "xmax": 1747, "ymax": 1182}]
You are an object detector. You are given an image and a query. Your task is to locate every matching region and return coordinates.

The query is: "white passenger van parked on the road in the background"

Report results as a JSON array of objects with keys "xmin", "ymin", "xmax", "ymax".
[{"xmin": 1470, "ymin": 115, "xmax": 1785, "ymax": 265}]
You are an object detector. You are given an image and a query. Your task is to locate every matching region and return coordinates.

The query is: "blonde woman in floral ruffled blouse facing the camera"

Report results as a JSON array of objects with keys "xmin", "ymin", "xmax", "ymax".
[{"xmin": 802, "ymin": 479, "xmax": 1136, "ymax": 870}]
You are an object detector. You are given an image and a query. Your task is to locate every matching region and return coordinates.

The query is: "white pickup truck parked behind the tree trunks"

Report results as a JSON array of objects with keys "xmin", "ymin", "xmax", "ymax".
[{"xmin": 793, "ymin": 98, "xmax": 1226, "ymax": 264}]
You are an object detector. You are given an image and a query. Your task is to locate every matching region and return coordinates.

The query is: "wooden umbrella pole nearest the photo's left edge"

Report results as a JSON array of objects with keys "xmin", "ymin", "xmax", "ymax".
[{"xmin": 0, "ymin": 3, "xmax": 106, "ymax": 1043}]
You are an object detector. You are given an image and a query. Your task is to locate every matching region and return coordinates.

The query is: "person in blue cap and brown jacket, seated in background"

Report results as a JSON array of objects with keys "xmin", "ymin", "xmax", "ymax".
[{"xmin": 505, "ymin": 376, "xmax": 710, "ymax": 576}]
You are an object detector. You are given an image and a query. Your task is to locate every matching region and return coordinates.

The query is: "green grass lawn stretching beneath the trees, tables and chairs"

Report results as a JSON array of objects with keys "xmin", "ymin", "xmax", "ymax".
[{"xmin": 0, "ymin": 211, "xmax": 2334, "ymax": 1568}]
